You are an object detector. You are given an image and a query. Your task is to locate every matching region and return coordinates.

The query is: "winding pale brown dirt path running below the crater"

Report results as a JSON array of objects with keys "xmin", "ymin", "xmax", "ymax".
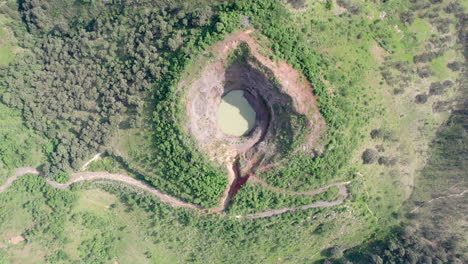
[{"xmin": 0, "ymin": 167, "xmax": 350, "ymax": 219}]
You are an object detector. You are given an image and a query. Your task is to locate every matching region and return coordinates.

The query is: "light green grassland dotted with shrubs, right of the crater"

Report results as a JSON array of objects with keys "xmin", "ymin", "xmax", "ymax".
[{"xmin": 250, "ymin": 1, "xmax": 462, "ymax": 256}]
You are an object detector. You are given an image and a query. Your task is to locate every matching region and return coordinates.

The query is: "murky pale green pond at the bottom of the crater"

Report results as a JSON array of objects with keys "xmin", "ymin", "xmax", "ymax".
[{"xmin": 218, "ymin": 90, "xmax": 256, "ymax": 136}]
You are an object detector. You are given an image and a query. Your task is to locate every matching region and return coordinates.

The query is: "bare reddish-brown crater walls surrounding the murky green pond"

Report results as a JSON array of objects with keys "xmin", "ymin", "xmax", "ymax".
[{"xmin": 181, "ymin": 30, "xmax": 326, "ymax": 209}]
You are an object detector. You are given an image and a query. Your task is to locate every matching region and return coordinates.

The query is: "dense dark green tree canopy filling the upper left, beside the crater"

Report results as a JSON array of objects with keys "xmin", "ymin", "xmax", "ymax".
[{"xmin": 1, "ymin": 1, "xmax": 232, "ymax": 206}]
